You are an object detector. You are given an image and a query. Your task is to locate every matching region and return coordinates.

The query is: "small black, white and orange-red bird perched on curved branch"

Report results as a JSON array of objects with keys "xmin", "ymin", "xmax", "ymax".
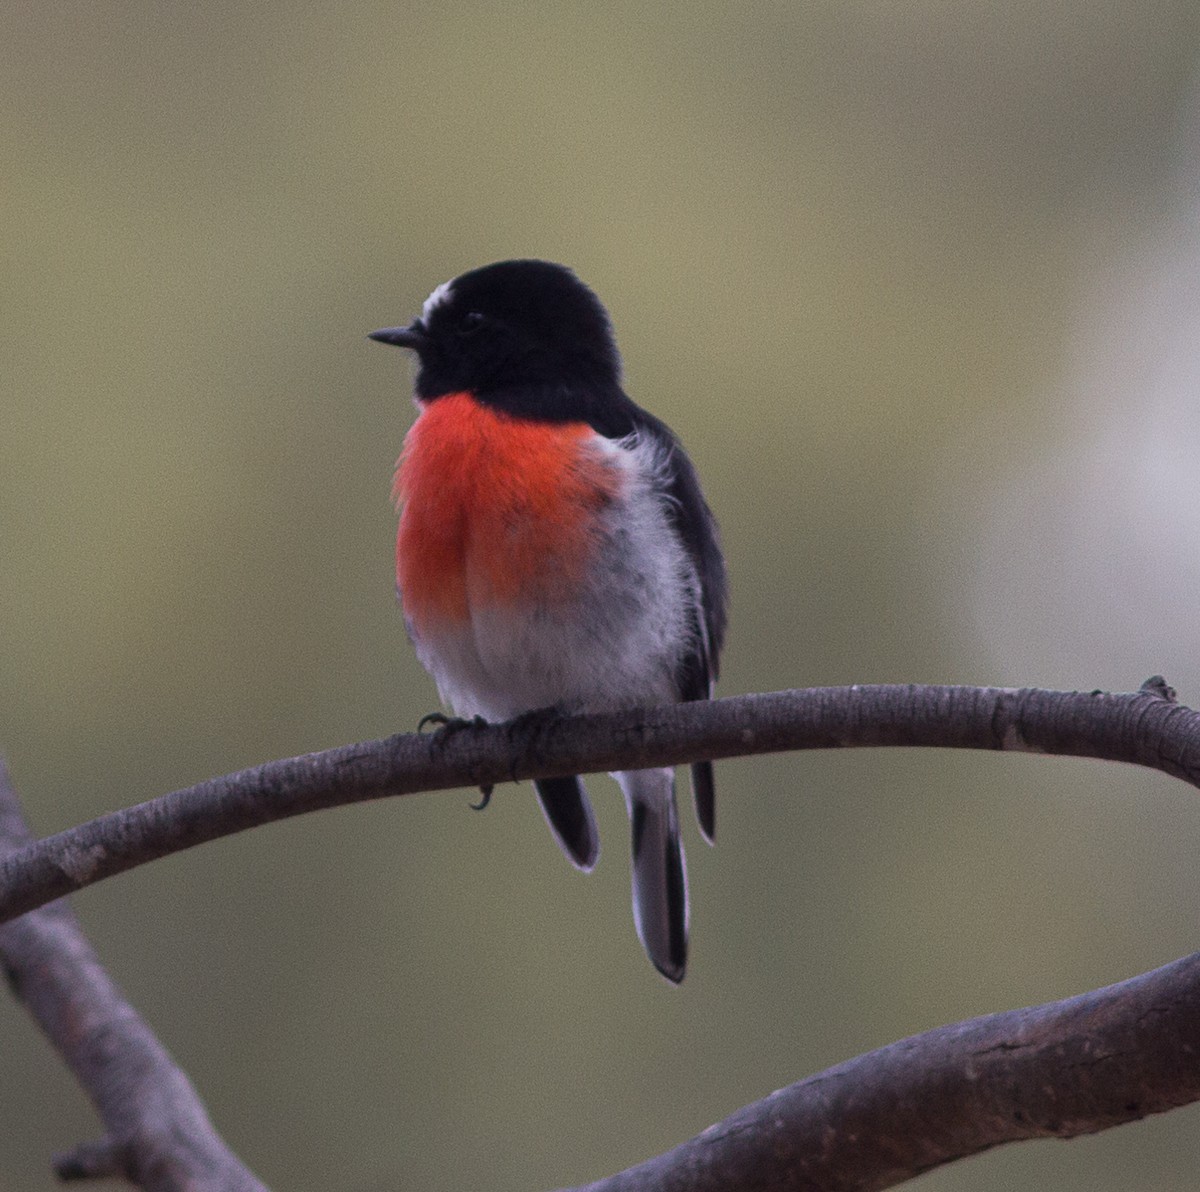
[{"xmin": 370, "ymin": 259, "xmax": 728, "ymax": 984}]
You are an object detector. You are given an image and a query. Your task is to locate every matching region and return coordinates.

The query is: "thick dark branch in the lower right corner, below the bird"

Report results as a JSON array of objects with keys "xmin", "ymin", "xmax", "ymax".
[{"xmin": 559, "ymin": 953, "xmax": 1200, "ymax": 1192}]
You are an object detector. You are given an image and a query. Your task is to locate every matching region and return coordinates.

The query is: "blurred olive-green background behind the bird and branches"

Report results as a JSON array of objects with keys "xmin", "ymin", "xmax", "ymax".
[{"xmin": 0, "ymin": 0, "xmax": 1200, "ymax": 1192}]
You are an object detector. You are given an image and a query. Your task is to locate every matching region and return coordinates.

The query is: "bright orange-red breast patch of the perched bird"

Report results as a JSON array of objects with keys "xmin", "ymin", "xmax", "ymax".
[{"xmin": 392, "ymin": 394, "xmax": 622, "ymax": 629}]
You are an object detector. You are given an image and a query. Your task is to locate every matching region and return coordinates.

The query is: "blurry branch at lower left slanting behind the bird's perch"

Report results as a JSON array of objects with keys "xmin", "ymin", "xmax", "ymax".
[{"xmin": 0, "ymin": 761, "xmax": 266, "ymax": 1192}]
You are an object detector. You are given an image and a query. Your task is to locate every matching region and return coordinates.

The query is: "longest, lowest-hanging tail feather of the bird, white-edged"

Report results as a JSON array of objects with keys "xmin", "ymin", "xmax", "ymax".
[{"xmin": 613, "ymin": 769, "xmax": 688, "ymax": 984}]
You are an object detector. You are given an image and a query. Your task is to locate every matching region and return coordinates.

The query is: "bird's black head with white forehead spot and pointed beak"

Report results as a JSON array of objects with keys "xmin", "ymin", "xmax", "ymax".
[{"xmin": 371, "ymin": 260, "xmax": 620, "ymax": 418}]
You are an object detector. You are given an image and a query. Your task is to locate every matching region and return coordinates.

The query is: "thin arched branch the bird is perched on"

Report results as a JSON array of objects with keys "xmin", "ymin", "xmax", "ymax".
[{"xmin": 0, "ymin": 677, "xmax": 1200, "ymax": 922}]
